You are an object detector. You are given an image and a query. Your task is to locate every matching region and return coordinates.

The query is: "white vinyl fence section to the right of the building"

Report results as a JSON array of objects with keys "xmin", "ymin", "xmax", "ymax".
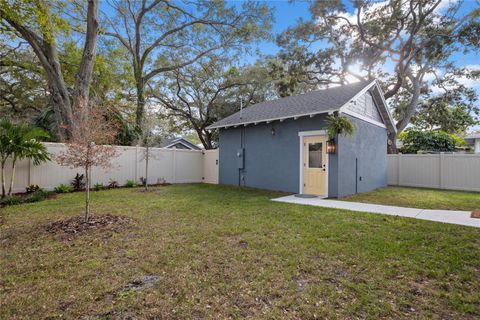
[{"xmin": 388, "ymin": 153, "xmax": 480, "ymax": 191}]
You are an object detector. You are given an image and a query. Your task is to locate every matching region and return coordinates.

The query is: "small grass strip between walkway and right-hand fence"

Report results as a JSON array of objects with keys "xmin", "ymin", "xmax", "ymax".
[{"xmin": 341, "ymin": 187, "xmax": 480, "ymax": 211}]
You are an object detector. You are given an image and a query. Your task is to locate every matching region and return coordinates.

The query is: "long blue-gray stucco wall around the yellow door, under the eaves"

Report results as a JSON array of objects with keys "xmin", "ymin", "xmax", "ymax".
[{"xmin": 219, "ymin": 115, "xmax": 336, "ymax": 193}]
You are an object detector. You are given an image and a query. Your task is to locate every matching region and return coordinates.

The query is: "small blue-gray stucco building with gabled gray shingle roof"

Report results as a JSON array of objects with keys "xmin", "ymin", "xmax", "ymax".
[{"xmin": 210, "ymin": 81, "xmax": 395, "ymax": 197}]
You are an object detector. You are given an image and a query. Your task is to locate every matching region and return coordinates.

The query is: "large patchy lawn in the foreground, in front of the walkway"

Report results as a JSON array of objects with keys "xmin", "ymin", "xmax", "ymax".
[{"xmin": 0, "ymin": 184, "xmax": 480, "ymax": 319}]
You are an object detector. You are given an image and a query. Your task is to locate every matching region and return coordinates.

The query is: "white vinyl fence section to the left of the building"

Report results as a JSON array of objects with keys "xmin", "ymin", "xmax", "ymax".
[{"xmin": 6, "ymin": 143, "xmax": 218, "ymax": 192}]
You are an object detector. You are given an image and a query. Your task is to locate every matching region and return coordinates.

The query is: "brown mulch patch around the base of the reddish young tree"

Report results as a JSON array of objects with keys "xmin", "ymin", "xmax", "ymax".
[{"xmin": 45, "ymin": 214, "xmax": 131, "ymax": 236}]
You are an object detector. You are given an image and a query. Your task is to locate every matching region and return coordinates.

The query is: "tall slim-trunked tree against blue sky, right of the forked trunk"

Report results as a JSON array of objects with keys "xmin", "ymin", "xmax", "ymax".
[{"xmin": 105, "ymin": 0, "xmax": 272, "ymax": 134}]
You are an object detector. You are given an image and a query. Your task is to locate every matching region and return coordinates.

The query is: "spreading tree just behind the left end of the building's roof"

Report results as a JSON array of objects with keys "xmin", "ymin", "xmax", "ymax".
[{"xmin": 151, "ymin": 57, "xmax": 272, "ymax": 149}]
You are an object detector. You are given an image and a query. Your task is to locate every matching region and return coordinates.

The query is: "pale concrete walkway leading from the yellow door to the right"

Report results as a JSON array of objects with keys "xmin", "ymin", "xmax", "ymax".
[{"xmin": 272, "ymin": 195, "xmax": 480, "ymax": 228}]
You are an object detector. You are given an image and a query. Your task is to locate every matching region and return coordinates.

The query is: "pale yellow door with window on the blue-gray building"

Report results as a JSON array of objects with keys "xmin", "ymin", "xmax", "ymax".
[{"xmin": 303, "ymin": 135, "xmax": 328, "ymax": 196}]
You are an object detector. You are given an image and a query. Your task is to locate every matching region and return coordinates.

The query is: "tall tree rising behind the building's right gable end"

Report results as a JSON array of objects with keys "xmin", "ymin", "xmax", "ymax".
[{"xmin": 272, "ymin": 0, "xmax": 480, "ymax": 152}]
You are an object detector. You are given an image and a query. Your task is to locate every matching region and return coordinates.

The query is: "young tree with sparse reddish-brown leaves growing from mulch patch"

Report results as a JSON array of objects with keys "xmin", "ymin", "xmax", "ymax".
[{"xmin": 56, "ymin": 105, "xmax": 118, "ymax": 222}]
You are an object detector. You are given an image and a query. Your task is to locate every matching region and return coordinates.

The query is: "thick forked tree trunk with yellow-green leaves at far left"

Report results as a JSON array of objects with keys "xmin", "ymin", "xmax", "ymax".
[{"xmin": 0, "ymin": 0, "xmax": 99, "ymax": 139}]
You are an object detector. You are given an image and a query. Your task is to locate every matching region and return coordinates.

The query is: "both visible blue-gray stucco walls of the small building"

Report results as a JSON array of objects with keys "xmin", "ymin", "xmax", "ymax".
[{"xmin": 219, "ymin": 99, "xmax": 387, "ymax": 197}]
